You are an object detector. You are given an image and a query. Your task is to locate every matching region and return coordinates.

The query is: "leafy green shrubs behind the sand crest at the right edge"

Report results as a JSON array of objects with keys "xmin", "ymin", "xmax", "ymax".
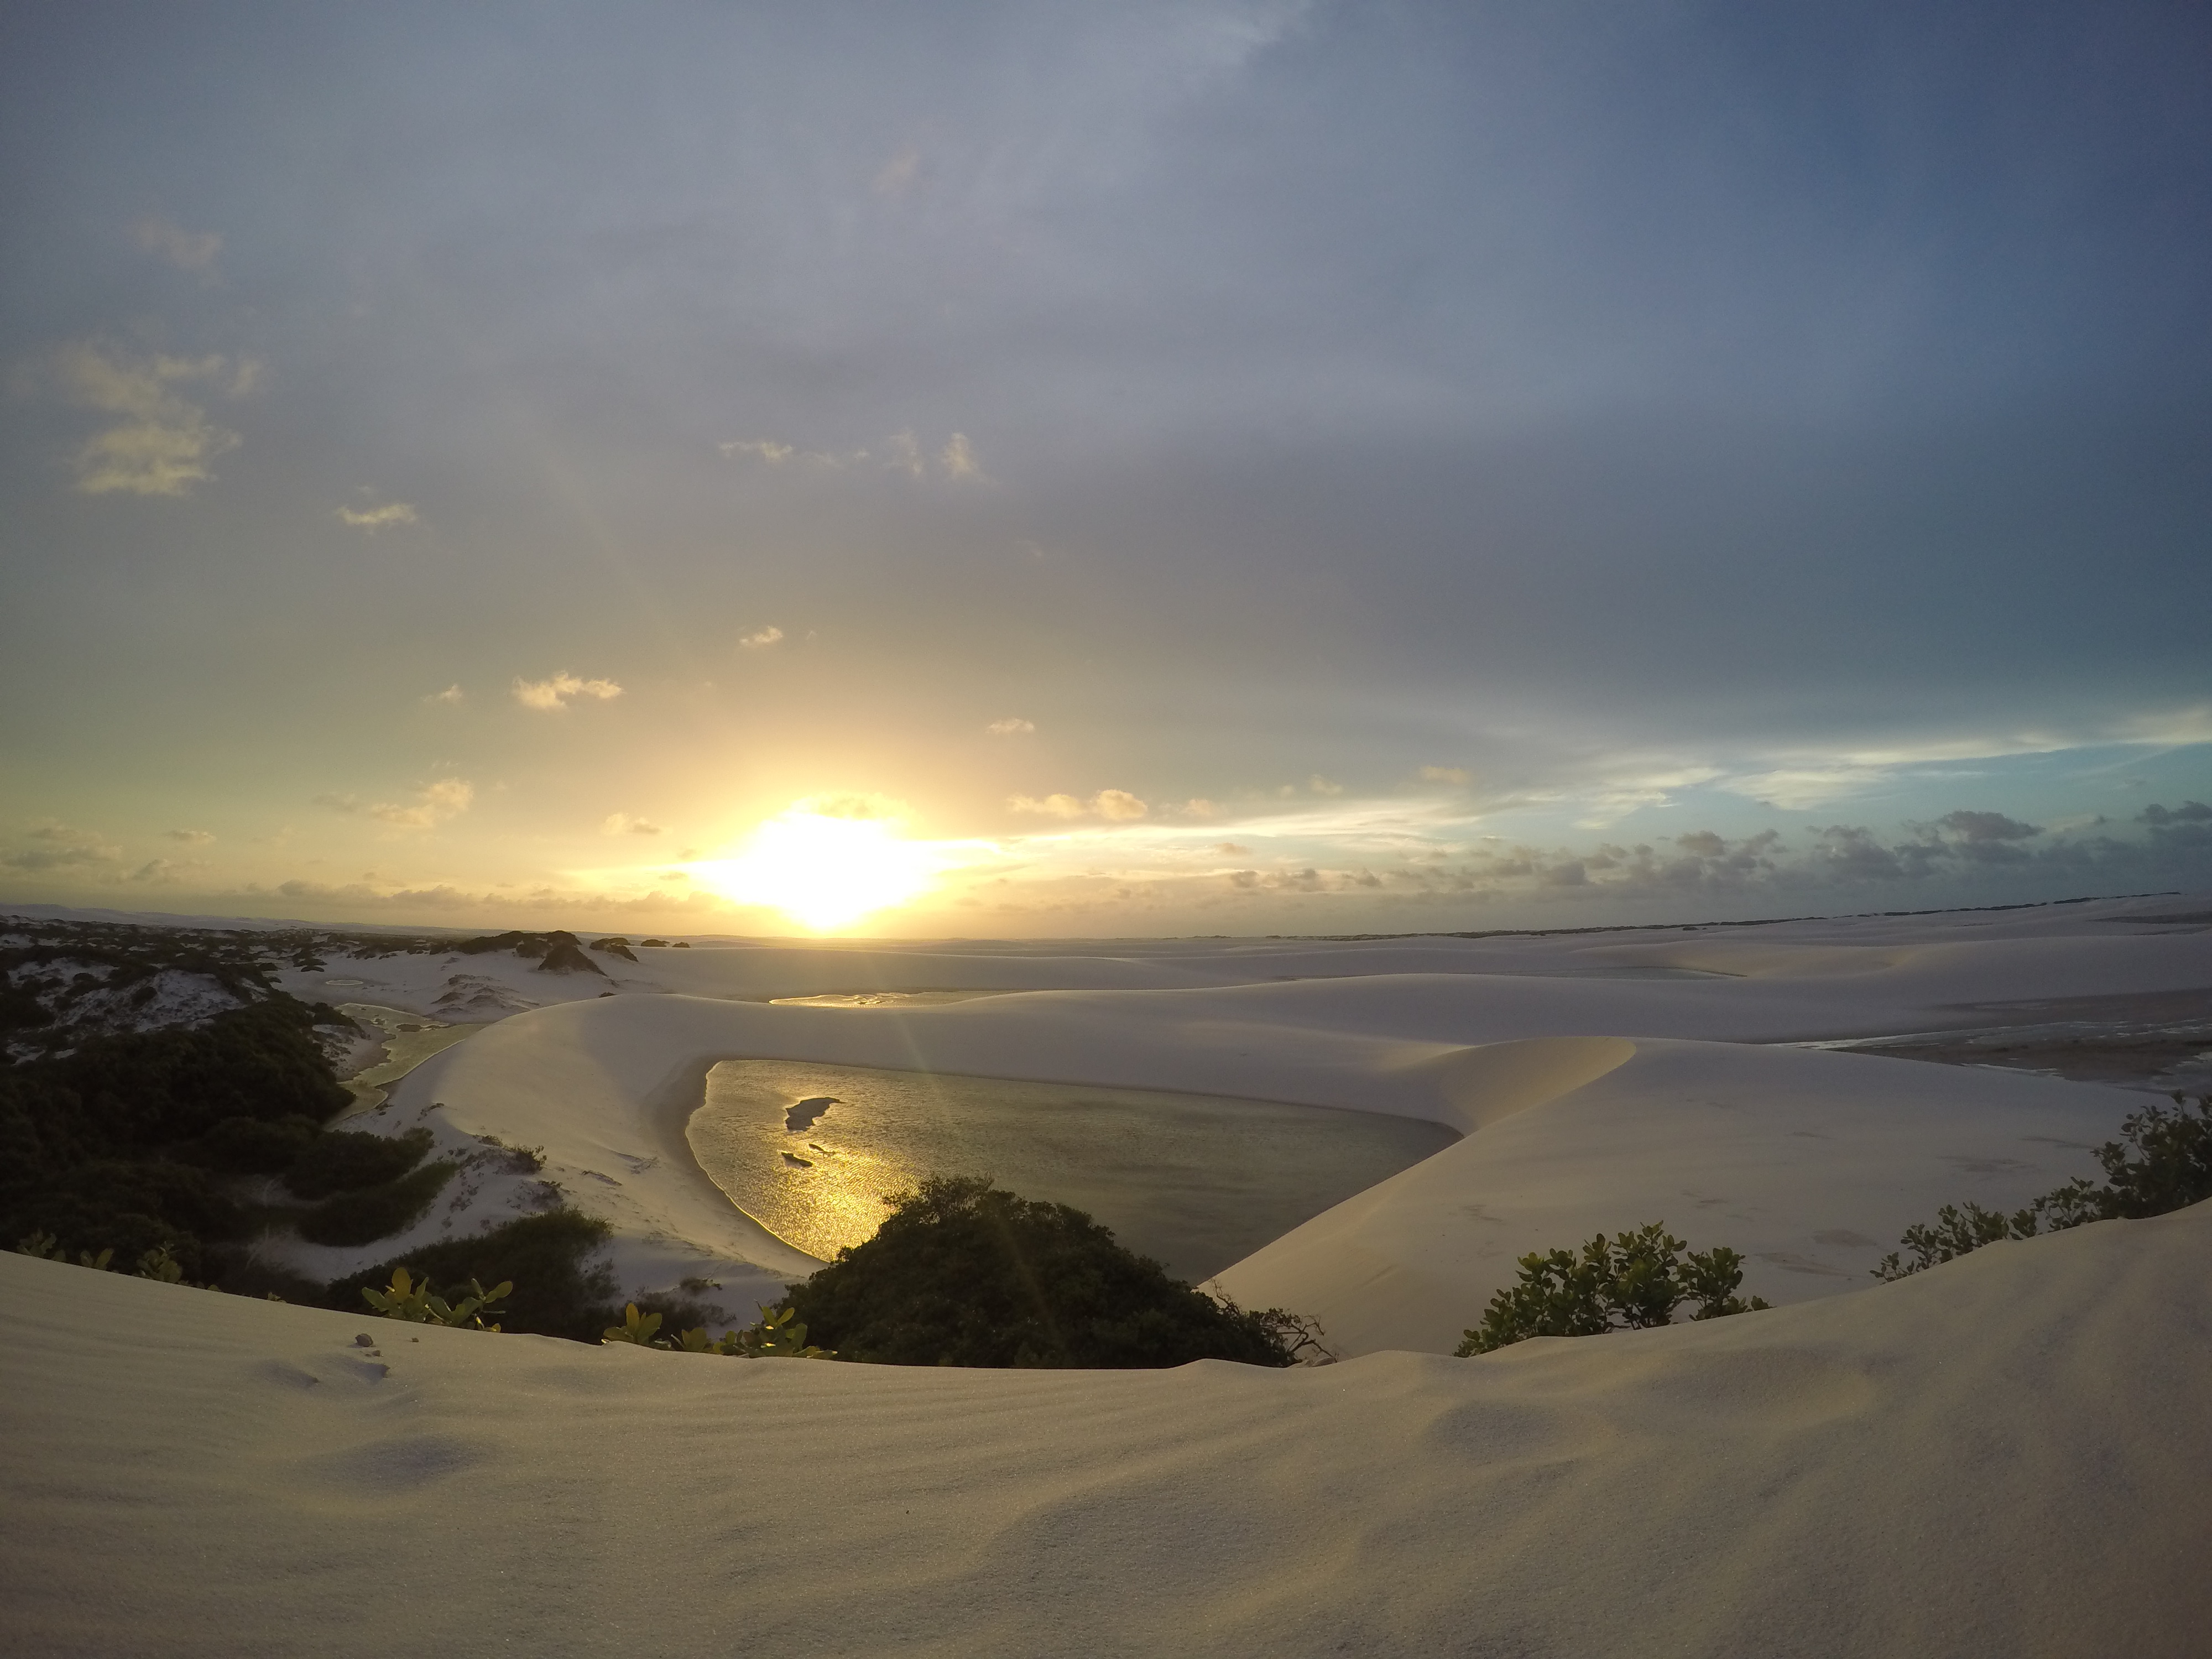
[{"xmin": 1874, "ymin": 1091, "xmax": 2212, "ymax": 1279}]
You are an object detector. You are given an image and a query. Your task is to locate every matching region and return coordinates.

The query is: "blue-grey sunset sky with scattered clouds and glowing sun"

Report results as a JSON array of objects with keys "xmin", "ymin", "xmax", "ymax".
[{"xmin": 0, "ymin": 0, "xmax": 2212, "ymax": 938}]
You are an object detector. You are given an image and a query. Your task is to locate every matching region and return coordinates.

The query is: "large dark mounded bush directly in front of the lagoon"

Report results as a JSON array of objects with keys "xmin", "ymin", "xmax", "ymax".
[{"xmin": 779, "ymin": 1177, "xmax": 1292, "ymax": 1369}]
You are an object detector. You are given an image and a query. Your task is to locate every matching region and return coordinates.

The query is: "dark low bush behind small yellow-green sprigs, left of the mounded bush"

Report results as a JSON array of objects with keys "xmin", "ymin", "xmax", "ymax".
[{"xmin": 323, "ymin": 1210, "xmax": 622, "ymax": 1343}]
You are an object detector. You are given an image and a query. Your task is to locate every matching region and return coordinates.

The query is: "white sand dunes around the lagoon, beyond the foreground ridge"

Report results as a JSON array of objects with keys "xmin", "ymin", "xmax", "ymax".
[{"xmin": 294, "ymin": 900, "xmax": 2212, "ymax": 1327}]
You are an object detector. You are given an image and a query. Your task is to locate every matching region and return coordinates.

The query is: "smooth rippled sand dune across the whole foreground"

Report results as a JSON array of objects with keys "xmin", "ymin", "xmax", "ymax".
[{"xmin": 0, "ymin": 1206, "xmax": 2212, "ymax": 1659}]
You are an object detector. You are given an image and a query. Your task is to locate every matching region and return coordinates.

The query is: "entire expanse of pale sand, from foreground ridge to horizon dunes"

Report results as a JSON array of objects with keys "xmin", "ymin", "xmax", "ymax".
[{"xmin": 0, "ymin": 898, "xmax": 2212, "ymax": 1659}]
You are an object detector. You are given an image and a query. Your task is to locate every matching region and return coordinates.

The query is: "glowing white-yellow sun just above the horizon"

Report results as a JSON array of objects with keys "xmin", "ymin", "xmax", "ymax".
[{"xmin": 688, "ymin": 801, "xmax": 931, "ymax": 933}]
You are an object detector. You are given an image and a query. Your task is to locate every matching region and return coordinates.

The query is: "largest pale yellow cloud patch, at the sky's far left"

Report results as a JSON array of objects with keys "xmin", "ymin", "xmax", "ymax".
[{"xmin": 55, "ymin": 343, "xmax": 247, "ymax": 495}]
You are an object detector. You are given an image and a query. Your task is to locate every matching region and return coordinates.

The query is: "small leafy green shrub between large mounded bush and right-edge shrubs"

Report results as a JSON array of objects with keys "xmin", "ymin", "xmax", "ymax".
[{"xmin": 1455, "ymin": 1221, "xmax": 1767, "ymax": 1358}]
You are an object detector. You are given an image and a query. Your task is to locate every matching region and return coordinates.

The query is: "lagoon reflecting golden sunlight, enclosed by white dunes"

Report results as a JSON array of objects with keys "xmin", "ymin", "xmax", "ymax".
[{"xmin": 686, "ymin": 1060, "xmax": 1458, "ymax": 1283}]
